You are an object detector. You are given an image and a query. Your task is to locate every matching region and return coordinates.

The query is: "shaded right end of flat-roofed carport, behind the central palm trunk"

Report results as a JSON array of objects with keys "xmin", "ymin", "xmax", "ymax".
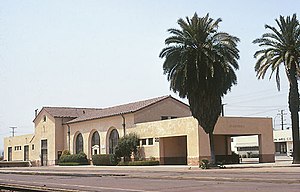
[{"xmin": 199, "ymin": 117, "xmax": 275, "ymax": 163}]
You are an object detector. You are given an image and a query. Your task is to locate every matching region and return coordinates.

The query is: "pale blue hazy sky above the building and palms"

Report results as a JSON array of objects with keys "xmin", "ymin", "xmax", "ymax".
[{"xmin": 0, "ymin": 0, "xmax": 300, "ymax": 152}]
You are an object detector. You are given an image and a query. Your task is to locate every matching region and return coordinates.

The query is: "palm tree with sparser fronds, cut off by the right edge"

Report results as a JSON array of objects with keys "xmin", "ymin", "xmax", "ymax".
[{"xmin": 253, "ymin": 14, "xmax": 300, "ymax": 163}]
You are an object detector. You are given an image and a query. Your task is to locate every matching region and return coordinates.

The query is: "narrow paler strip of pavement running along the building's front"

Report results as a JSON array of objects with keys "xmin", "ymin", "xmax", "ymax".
[{"xmin": 0, "ymin": 159, "xmax": 300, "ymax": 178}]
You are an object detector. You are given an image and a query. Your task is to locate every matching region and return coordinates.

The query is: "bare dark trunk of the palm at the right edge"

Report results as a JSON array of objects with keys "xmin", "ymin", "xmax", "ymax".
[{"xmin": 289, "ymin": 65, "xmax": 300, "ymax": 164}]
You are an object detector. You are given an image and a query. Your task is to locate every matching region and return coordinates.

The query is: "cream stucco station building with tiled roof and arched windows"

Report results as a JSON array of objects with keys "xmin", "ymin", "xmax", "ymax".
[{"xmin": 4, "ymin": 96, "xmax": 275, "ymax": 166}]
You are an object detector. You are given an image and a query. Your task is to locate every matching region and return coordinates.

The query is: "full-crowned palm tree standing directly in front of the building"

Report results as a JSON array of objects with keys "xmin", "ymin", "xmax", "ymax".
[{"xmin": 159, "ymin": 13, "xmax": 239, "ymax": 163}]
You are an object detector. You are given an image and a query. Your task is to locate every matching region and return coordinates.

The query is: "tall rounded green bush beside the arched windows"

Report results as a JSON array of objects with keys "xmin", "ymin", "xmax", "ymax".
[{"xmin": 115, "ymin": 133, "xmax": 140, "ymax": 161}]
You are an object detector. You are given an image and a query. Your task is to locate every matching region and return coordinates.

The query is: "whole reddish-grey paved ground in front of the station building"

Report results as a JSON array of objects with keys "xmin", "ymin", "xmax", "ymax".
[{"xmin": 0, "ymin": 159, "xmax": 300, "ymax": 191}]
